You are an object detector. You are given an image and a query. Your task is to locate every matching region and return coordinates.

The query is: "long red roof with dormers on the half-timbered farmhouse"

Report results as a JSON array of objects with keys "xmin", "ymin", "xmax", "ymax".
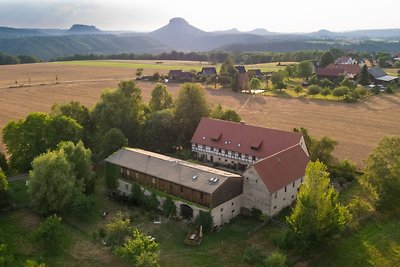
[{"xmin": 191, "ymin": 118, "xmax": 302, "ymax": 158}]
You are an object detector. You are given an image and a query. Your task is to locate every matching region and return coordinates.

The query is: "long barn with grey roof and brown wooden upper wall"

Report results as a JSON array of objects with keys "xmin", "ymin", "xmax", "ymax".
[{"xmin": 105, "ymin": 148, "xmax": 243, "ymax": 225}]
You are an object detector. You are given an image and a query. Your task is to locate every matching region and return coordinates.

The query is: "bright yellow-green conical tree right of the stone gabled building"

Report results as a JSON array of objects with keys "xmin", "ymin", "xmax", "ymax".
[{"xmin": 287, "ymin": 161, "xmax": 347, "ymax": 252}]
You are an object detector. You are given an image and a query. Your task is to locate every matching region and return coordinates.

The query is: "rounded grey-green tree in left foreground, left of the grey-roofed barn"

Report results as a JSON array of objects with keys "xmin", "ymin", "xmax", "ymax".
[{"xmin": 28, "ymin": 151, "xmax": 79, "ymax": 214}]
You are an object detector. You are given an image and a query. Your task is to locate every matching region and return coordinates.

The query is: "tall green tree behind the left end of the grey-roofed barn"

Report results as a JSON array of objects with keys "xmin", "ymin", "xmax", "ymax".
[{"xmin": 91, "ymin": 81, "xmax": 144, "ymax": 146}]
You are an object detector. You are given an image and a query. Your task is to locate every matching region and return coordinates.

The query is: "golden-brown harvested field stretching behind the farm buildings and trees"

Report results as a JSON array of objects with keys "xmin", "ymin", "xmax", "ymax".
[{"xmin": 0, "ymin": 61, "xmax": 400, "ymax": 167}]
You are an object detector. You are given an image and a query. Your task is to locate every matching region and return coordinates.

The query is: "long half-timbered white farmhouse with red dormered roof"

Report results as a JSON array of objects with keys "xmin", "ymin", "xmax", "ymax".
[{"xmin": 191, "ymin": 118, "xmax": 308, "ymax": 170}]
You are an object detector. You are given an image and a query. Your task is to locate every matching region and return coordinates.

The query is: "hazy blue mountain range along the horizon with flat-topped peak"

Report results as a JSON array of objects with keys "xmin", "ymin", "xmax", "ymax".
[{"xmin": 0, "ymin": 18, "xmax": 400, "ymax": 60}]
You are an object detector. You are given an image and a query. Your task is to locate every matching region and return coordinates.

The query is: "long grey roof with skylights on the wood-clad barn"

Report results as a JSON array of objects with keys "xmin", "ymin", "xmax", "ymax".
[{"xmin": 106, "ymin": 147, "xmax": 241, "ymax": 194}]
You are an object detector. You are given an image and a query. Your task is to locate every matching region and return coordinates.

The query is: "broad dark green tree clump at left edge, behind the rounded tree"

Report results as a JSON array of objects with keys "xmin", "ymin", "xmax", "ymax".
[{"xmin": 3, "ymin": 112, "xmax": 83, "ymax": 172}]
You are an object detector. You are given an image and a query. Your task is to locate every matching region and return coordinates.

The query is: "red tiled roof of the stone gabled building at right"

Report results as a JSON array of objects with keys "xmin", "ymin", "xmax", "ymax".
[{"xmin": 253, "ymin": 145, "xmax": 310, "ymax": 193}]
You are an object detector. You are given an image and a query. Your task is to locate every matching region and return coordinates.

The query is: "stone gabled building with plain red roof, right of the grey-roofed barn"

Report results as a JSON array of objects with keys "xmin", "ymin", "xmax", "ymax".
[{"xmin": 242, "ymin": 144, "xmax": 309, "ymax": 216}]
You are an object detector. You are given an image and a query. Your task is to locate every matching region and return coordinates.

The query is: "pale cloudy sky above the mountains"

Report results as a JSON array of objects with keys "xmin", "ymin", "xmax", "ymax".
[{"xmin": 0, "ymin": 0, "xmax": 400, "ymax": 33}]
